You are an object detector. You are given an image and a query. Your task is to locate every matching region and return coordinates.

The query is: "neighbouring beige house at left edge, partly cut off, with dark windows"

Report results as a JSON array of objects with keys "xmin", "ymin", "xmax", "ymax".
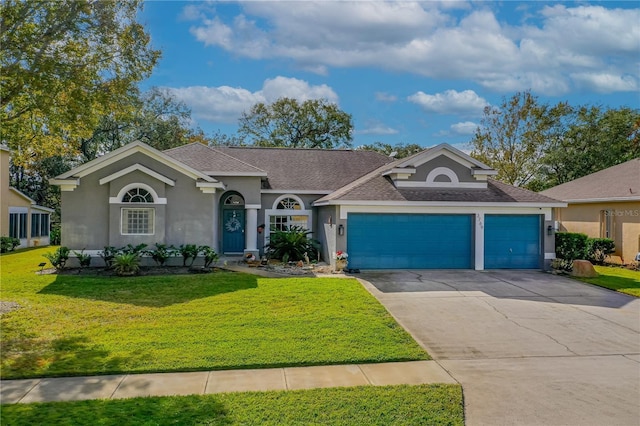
[{"xmin": 0, "ymin": 147, "xmax": 53, "ymax": 247}]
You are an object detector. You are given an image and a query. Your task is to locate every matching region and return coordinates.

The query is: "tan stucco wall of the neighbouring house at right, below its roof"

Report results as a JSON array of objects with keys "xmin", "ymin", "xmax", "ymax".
[{"xmin": 554, "ymin": 201, "xmax": 640, "ymax": 263}]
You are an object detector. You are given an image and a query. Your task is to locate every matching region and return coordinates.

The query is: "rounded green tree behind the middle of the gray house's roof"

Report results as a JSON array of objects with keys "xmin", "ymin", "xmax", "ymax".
[{"xmin": 239, "ymin": 98, "xmax": 353, "ymax": 149}]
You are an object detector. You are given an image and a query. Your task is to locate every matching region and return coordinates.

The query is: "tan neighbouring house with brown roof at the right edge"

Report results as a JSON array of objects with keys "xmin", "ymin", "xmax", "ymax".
[{"xmin": 541, "ymin": 158, "xmax": 640, "ymax": 264}]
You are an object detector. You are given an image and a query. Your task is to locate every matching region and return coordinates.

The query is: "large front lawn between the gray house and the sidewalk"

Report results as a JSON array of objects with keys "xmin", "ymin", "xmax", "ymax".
[{"xmin": 0, "ymin": 248, "xmax": 428, "ymax": 380}]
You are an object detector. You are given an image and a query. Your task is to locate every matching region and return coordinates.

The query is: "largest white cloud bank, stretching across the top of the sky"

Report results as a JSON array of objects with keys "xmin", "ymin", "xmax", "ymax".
[{"xmin": 184, "ymin": 1, "xmax": 640, "ymax": 95}]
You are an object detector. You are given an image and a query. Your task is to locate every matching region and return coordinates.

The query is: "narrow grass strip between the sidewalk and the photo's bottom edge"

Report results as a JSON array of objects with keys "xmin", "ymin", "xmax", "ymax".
[{"xmin": 0, "ymin": 385, "xmax": 464, "ymax": 426}]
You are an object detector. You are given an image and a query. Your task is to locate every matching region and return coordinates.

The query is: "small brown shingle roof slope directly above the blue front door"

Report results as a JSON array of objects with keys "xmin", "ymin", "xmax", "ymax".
[{"xmin": 163, "ymin": 142, "xmax": 267, "ymax": 176}]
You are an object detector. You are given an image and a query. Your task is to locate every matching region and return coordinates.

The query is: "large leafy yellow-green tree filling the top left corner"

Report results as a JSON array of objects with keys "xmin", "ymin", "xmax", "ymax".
[{"xmin": 0, "ymin": 0, "xmax": 160, "ymax": 165}]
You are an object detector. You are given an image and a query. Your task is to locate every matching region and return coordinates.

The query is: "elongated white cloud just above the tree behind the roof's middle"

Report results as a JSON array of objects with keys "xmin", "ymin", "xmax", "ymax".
[{"xmin": 167, "ymin": 76, "xmax": 338, "ymax": 123}]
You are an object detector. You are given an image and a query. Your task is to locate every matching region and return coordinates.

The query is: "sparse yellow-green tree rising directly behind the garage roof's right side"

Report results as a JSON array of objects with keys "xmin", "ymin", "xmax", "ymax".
[{"xmin": 471, "ymin": 91, "xmax": 570, "ymax": 187}]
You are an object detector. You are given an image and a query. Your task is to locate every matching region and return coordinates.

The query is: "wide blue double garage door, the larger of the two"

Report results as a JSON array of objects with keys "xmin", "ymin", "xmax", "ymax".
[{"xmin": 347, "ymin": 213, "xmax": 473, "ymax": 269}]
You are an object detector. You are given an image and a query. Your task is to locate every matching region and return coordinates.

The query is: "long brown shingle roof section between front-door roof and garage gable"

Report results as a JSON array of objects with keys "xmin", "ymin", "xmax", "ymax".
[{"xmin": 216, "ymin": 147, "xmax": 393, "ymax": 192}]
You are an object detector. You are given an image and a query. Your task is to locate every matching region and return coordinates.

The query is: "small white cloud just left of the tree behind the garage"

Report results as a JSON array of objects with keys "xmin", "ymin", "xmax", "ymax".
[{"xmin": 407, "ymin": 90, "xmax": 488, "ymax": 115}]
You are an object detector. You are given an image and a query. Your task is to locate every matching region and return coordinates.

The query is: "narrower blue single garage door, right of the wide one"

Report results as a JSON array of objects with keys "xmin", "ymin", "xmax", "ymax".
[{"xmin": 484, "ymin": 215, "xmax": 542, "ymax": 269}]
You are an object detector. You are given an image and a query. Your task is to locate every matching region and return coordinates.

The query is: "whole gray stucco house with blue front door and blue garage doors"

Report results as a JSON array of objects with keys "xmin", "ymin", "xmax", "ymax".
[{"xmin": 51, "ymin": 142, "xmax": 566, "ymax": 269}]
